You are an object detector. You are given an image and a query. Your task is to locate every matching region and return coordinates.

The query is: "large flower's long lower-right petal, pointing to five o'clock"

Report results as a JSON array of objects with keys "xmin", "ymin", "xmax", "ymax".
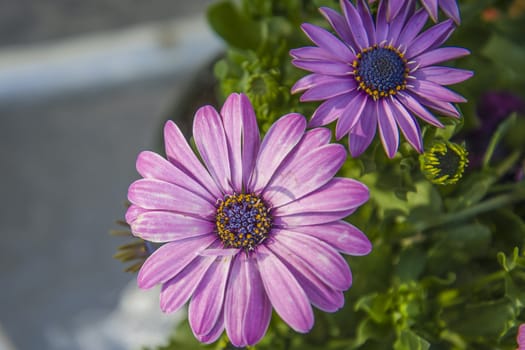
[{"xmin": 257, "ymin": 245, "xmax": 314, "ymax": 333}]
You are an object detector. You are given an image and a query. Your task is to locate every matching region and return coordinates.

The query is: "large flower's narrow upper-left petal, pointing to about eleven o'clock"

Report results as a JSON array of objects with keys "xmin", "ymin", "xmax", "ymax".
[{"xmin": 164, "ymin": 120, "xmax": 222, "ymax": 198}]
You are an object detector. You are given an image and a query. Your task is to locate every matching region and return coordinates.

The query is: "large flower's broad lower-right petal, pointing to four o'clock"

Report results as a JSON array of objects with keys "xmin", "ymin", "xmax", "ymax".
[{"xmin": 268, "ymin": 230, "xmax": 352, "ymax": 291}]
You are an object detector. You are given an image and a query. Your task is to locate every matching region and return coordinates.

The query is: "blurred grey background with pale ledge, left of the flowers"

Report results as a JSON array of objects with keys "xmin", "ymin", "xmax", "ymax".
[{"xmin": 0, "ymin": 0, "xmax": 222, "ymax": 350}]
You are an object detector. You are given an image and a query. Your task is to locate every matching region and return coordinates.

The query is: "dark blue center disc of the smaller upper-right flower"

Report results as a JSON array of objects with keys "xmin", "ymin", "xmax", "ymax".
[{"xmin": 352, "ymin": 45, "xmax": 409, "ymax": 99}]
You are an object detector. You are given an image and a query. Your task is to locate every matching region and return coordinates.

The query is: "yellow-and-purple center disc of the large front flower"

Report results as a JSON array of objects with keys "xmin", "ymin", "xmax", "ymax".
[{"xmin": 215, "ymin": 193, "xmax": 272, "ymax": 250}]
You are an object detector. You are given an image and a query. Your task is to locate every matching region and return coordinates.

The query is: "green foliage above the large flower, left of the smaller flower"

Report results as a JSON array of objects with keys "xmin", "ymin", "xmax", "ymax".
[{"xmin": 207, "ymin": 0, "xmax": 336, "ymax": 131}]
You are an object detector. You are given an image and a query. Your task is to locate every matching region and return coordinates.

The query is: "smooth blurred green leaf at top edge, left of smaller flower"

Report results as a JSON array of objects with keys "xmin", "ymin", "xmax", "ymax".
[{"xmin": 206, "ymin": 1, "xmax": 262, "ymax": 49}]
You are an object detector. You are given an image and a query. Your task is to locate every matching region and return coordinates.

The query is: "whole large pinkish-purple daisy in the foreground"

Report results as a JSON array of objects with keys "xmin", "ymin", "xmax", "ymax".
[{"xmin": 126, "ymin": 94, "xmax": 371, "ymax": 346}]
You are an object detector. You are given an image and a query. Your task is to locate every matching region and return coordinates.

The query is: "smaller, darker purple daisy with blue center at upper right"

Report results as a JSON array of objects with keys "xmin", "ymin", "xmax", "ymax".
[{"xmin": 290, "ymin": 0, "xmax": 472, "ymax": 158}]
